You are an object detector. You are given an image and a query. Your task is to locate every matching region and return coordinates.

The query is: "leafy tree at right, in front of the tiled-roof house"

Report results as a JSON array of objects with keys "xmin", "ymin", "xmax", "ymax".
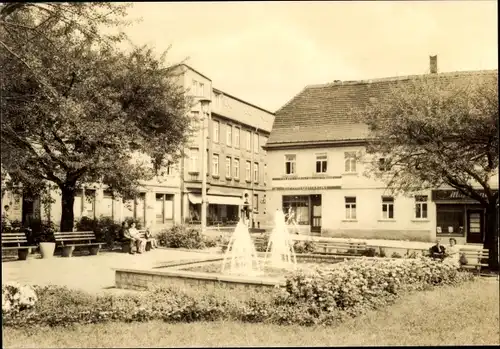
[{"xmin": 355, "ymin": 71, "xmax": 498, "ymax": 269}]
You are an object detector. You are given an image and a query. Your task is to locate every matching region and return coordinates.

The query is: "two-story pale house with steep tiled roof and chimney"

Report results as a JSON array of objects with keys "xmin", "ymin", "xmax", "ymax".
[{"xmin": 265, "ymin": 58, "xmax": 498, "ymax": 243}]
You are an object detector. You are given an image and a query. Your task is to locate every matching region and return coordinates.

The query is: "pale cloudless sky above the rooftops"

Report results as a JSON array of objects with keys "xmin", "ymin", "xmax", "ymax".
[{"xmin": 125, "ymin": 0, "xmax": 498, "ymax": 112}]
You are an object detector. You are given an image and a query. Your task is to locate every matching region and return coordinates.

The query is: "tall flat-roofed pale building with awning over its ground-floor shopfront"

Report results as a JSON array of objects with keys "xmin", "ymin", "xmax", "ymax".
[{"xmin": 171, "ymin": 64, "xmax": 274, "ymax": 226}]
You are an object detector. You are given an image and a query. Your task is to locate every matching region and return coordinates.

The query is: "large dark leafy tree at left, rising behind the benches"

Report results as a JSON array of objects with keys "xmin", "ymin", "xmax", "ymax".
[{"xmin": 0, "ymin": 3, "xmax": 195, "ymax": 231}]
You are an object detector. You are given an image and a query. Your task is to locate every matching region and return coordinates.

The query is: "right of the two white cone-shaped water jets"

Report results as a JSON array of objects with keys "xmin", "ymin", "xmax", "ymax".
[{"xmin": 265, "ymin": 210, "xmax": 297, "ymax": 269}]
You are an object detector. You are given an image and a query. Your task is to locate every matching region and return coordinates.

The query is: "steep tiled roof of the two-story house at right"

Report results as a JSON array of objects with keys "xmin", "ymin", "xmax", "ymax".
[{"xmin": 267, "ymin": 70, "xmax": 498, "ymax": 146}]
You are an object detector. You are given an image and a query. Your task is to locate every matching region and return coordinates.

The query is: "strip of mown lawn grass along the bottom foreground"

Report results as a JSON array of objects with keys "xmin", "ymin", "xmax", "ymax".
[{"xmin": 3, "ymin": 279, "xmax": 500, "ymax": 348}]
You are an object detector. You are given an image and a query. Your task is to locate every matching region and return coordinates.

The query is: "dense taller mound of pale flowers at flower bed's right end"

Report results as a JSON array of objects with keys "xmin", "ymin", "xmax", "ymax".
[{"xmin": 286, "ymin": 258, "xmax": 473, "ymax": 313}]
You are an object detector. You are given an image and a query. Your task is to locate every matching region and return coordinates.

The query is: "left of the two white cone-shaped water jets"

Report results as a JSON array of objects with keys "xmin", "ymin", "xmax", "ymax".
[{"xmin": 221, "ymin": 219, "xmax": 261, "ymax": 276}]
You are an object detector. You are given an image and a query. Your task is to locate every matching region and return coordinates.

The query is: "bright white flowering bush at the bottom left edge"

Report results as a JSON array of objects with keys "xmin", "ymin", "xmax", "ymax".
[{"xmin": 2, "ymin": 282, "xmax": 38, "ymax": 313}]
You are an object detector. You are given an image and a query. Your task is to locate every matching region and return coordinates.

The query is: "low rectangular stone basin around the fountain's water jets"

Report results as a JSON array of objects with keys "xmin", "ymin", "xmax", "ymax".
[{"xmin": 115, "ymin": 254, "xmax": 344, "ymax": 290}]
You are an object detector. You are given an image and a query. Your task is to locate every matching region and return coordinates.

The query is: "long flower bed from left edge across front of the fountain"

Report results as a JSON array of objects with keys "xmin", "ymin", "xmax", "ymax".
[{"xmin": 2, "ymin": 259, "xmax": 474, "ymax": 327}]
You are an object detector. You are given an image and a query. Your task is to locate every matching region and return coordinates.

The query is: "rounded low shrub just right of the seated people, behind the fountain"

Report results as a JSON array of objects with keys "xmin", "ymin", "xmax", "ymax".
[{"xmin": 157, "ymin": 225, "xmax": 207, "ymax": 249}]
